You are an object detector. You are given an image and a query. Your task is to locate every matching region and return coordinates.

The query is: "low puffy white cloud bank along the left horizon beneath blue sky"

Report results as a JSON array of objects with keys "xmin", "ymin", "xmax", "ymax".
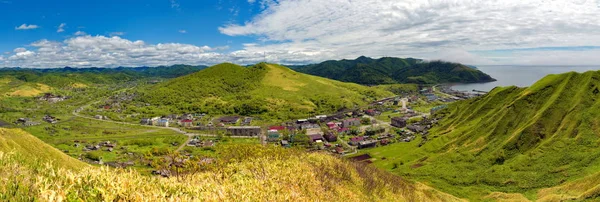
[{"xmin": 0, "ymin": 35, "xmax": 230, "ymax": 68}]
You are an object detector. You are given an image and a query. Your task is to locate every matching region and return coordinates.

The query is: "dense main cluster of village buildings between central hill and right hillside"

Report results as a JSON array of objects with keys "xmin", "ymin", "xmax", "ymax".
[{"xmin": 120, "ymin": 86, "xmax": 482, "ymax": 155}]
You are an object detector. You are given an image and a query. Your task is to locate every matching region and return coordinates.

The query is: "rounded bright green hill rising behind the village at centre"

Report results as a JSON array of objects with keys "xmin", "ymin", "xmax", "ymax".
[{"xmin": 138, "ymin": 63, "xmax": 393, "ymax": 119}]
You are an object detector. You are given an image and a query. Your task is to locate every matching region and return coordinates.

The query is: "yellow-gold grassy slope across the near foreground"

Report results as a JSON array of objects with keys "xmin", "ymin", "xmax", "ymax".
[{"xmin": 0, "ymin": 129, "xmax": 460, "ymax": 201}]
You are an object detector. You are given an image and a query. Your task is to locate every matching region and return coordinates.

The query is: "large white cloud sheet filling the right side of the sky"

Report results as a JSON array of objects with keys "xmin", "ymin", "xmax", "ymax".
[{"xmin": 219, "ymin": 0, "xmax": 600, "ymax": 62}]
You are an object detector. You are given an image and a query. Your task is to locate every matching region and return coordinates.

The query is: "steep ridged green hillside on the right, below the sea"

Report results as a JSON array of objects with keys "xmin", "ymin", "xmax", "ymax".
[{"xmin": 360, "ymin": 72, "xmax": 600, "ymax": 200}]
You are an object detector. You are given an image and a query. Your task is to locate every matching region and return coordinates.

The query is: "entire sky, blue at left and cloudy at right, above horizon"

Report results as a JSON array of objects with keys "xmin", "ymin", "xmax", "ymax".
[{"xmin": 0, "ymin": 0, "xmax": 600, "ymax": 68}]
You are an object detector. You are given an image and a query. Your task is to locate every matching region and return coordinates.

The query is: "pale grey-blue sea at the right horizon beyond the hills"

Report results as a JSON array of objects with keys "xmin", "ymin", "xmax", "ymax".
[{"xmin": 452, "ymin": 66, "xmax": 600, "ymax": 92}]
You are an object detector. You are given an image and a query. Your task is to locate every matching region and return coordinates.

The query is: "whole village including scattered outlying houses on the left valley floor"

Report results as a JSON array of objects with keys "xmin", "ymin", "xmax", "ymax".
[{"xmin": 9, "ymin": 86, "xmax": 482, "ymax": 176}]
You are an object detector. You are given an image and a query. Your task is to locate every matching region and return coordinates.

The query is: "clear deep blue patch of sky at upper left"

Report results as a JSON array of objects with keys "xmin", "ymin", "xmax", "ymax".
[{"xmin": 0, "ymin": 0, "xmax": 260, "ymax": 52}]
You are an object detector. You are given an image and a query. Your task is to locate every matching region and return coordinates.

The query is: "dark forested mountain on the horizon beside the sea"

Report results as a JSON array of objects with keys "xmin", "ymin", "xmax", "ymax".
[{"xmin": 293, "ymin": 56, "xmax": 495, "ymax": 85}]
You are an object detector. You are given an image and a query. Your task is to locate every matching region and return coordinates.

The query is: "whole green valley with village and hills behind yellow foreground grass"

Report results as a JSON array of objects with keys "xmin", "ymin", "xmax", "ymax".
[{"xmin": 0, "ymin": 63, "xmax": 600, "ymax": 201}]
